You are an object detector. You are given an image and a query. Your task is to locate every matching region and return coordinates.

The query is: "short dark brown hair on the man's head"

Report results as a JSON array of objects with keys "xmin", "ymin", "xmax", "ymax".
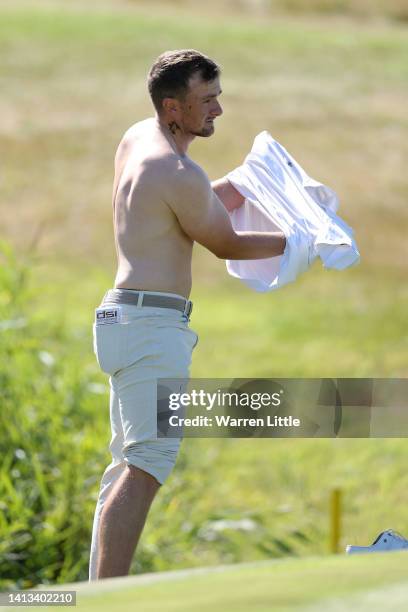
[{"xmin": 147, "ymin": 49, "xmax": 221, "ymax": 113}]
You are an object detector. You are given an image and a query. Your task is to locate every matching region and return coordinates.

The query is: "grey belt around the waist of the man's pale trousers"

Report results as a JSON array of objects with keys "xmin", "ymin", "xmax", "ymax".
[{"xmin": 102, "ymin": 289, "xmax": 193, "ymax": 317}]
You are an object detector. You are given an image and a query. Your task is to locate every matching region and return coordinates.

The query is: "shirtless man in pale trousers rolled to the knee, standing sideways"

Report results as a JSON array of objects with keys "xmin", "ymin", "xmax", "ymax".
[{"xmin": 89, "ymin": 49, "xmax": 285, "ymax": 580}]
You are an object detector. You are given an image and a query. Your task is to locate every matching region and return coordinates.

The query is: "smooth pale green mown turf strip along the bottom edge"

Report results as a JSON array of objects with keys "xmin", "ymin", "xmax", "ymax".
[{"xmin": 5, "ymin": 552, "xmax": 408, "ymax": 612}]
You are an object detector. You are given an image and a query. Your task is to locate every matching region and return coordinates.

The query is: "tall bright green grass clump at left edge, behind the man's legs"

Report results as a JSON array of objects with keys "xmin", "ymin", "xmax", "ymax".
[{"xmin": 0, "ymin": 243, "xmax": 107, "ymax": 588}]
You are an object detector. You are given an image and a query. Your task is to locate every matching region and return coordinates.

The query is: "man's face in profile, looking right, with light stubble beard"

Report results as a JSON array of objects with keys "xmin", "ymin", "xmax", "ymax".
[{"xmin": 180, "ymin": 74, "xmax": 222, "ymax": 136}]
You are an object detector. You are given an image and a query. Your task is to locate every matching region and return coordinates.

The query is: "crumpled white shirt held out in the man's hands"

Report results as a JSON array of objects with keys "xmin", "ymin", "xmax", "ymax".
[{"xmin": 226, "ymin": 131, "xmax": 360, "ymax": 291}]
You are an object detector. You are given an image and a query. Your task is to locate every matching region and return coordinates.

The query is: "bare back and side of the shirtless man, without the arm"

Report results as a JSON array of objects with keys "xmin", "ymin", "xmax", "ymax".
[{"xmin": 113, "ymin": 119, "xmax": 199, "ymax": 298}]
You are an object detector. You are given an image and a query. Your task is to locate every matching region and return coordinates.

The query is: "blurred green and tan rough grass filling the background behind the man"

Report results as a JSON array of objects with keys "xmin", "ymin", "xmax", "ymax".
[{"xmin": 0, "ymin": 1, "xmax": 408, "ymax": 592}]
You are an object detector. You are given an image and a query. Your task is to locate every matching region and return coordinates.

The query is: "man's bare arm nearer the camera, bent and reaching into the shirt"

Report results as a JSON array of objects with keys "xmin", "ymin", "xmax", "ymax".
[{"xmin": 168, "ymin": 166, "xmax": 286, "ymax": 259}]
